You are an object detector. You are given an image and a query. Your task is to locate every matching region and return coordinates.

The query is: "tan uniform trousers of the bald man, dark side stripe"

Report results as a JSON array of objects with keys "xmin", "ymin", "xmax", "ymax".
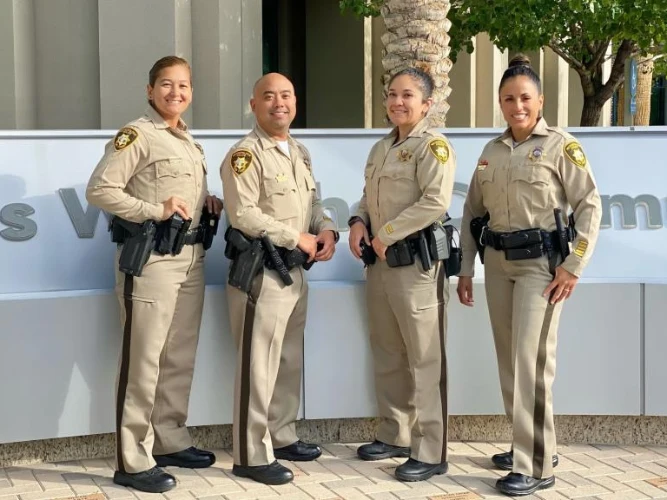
[{"xmin": 227, "ymin": 268, "xmax": 308, "ymax": 466}]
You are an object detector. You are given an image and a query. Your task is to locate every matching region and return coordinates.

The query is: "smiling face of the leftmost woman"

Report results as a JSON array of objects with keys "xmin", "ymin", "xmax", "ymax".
[{"xmin": 146, "ymin": 64, "xmax": 192, "ymax": 127}]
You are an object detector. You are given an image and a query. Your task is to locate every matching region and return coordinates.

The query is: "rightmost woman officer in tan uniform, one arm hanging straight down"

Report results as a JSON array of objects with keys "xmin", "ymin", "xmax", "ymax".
[{"xmin": 457, "ymin": 55, "xmax": 601, "ymax": 495}]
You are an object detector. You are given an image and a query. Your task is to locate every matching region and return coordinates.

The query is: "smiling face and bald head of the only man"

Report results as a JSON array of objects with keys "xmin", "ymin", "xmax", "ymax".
[{"xmin": 250, "ymin": 73, "xmax": 296, "ymax": 140}]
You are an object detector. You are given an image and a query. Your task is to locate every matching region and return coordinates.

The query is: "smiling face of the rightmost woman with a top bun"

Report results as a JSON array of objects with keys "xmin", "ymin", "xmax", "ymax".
[{"xmin": 499, "ymin": 75, "xmax": 544, "ymax": 141}]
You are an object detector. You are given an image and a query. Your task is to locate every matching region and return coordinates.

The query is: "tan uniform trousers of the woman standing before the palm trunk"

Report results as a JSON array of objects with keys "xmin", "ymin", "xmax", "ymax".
[{"xmin": 366, "ymin": 260, "xmax": 449, "ymax": 464}]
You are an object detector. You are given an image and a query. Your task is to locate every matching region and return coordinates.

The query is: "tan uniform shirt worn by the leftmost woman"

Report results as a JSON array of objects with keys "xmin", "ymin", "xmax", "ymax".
[{"xmin": 86, "ymin": 107, "xmax": 208, "ymax": 228}]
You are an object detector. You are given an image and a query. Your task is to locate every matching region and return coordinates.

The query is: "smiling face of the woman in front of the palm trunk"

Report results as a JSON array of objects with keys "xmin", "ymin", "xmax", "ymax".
[{"xmin": 387, "ymin": 75, "xmax": 432, "ymax": 132}]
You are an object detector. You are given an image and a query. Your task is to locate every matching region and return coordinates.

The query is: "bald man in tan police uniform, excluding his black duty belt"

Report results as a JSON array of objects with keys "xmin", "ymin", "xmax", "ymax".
[{"xmin": 220, "ymin": 73, "xmax": 338, "ymax": 484}]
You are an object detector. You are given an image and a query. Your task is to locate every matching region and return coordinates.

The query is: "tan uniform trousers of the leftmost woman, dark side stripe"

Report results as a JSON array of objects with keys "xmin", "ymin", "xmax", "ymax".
[{"xmin": 116, "ymin": 244, "xmax": 204, "ymax": 473}]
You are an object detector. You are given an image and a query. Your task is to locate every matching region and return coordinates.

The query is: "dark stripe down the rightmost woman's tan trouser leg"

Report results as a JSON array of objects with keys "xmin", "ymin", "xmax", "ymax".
[{"xmin": 533, "ymin": 304, "xmax": 555, "ymax": 478}]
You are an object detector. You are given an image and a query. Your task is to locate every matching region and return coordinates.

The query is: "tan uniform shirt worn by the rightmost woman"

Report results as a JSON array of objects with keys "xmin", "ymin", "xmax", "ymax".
[{"xmin": 459, "ymin": 118, "xmax": 602, "ymax": 276}]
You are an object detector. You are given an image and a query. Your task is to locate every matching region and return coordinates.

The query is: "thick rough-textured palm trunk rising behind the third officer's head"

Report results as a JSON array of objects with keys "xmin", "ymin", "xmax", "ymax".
[{"xmin": 382, "ymin": 0, "xmax": 452, "ymax": 127}]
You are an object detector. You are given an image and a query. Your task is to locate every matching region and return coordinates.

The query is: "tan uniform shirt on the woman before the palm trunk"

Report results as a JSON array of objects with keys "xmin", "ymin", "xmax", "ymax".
[{"xmin": 355, "ymin": 120, "xmax": 456, "ymax": 242}]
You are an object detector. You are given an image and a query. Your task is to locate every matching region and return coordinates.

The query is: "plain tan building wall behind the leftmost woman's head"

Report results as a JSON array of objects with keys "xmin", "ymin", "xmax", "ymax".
[{"xmin": 0, "ymin": 0, "xmax": 262, "ymax": 129}]
